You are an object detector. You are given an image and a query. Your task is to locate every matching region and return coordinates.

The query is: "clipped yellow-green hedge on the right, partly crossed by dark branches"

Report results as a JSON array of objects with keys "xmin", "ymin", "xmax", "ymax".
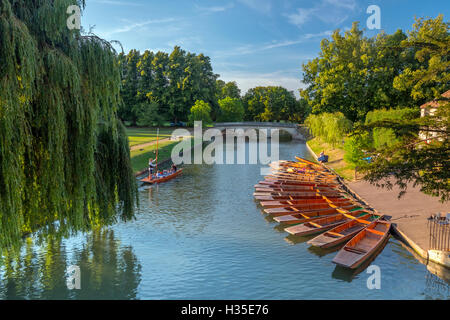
[{"xmin": 366, "ymin": 108, "xmax": 420, "ymax": 149}]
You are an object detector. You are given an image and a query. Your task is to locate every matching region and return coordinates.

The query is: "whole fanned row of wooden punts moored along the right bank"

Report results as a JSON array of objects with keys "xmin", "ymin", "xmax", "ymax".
[{"xmin": 253, "ymin": 157, "xmax": 391, "ymax": 269}]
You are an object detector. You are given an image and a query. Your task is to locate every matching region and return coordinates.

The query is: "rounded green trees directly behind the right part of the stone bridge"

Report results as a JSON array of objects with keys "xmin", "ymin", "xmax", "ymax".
[{"xmin": 243, "ymin": 87, "xmax": 306, "ymax": 122}]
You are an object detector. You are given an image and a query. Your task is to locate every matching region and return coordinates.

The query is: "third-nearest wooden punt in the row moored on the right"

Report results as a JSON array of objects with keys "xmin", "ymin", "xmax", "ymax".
[{"xmin": 284, "ymin": 213, "xmax": 368, "ymax": 236}]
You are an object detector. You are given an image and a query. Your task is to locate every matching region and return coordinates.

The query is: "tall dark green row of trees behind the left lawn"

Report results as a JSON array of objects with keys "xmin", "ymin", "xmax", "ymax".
[{"xmin": 118, "ymin": 46, "xmax": 218, "ymax": 125}]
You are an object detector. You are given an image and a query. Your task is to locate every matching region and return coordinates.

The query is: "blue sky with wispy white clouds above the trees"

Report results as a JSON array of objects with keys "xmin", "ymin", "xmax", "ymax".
[{"xmin": 82, "ymin": 0, "xmax": 450, "ymax": 97}]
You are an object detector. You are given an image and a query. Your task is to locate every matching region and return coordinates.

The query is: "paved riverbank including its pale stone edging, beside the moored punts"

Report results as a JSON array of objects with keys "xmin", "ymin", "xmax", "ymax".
[{"xmin": 306, "ymin": 141, "xmax": 450, "ymax": 268}]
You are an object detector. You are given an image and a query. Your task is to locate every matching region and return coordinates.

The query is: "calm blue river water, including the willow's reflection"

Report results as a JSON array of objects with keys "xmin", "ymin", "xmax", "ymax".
[{"xmin": 0, "ymin": 142, "xmax": 450, "ymax": 299}]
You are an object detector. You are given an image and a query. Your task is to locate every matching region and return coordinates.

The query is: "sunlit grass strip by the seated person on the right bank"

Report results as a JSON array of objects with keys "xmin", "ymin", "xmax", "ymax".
[{"xmin": 308, "ymin": 137, "xmax": 355, "ymax": 181}]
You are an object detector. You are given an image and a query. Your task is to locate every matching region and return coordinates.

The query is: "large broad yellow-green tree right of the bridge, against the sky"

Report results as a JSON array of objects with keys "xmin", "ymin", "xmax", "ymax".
[{"xmin": 301, "ymin": 22, "xmax": 415, "ymax": 121}]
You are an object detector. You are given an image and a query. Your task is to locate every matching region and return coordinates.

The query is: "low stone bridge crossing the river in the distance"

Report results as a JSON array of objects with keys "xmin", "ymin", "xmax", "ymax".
[{"xmin": 214, "ymin": 122, "xmax": 307, "ymax": 141}]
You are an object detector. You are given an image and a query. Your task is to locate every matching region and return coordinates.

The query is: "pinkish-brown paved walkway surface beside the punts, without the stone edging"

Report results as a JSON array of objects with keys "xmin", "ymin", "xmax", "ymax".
[{"xmin": 348, "ymin": 181, "xmax": 450, "ymax": 250}]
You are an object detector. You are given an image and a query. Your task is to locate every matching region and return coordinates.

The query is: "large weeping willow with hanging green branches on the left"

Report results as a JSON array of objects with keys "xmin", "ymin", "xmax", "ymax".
[{"xmin": 0, "ymin": 0, "xmax": 137, "ymax": 247}]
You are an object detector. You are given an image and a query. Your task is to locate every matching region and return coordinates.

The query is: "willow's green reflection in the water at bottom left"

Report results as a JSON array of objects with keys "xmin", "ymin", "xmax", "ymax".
[{"xmin": 0, "ymin": 229, "xmax": 141, "ymax": 299}]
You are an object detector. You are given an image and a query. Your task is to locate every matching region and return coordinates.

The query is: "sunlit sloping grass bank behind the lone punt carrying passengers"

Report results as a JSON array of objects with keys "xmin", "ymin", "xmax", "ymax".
[{"xmin": 131, "ymin": 141, "xmax": 192, "ymax": 172}]
